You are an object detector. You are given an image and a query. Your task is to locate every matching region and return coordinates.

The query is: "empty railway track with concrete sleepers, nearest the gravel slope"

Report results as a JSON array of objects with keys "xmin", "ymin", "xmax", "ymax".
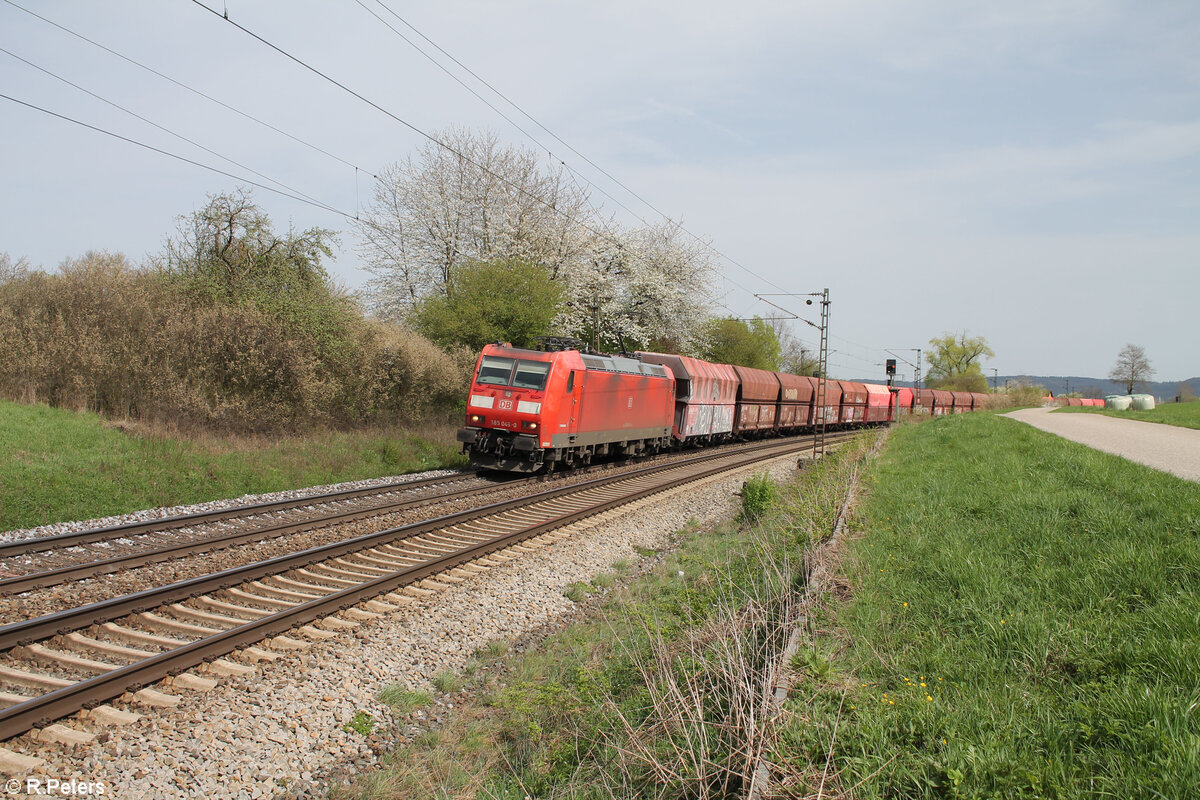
[{"xmin": 0, "ymin": 439, "xmax": 849, "ymax": 740}]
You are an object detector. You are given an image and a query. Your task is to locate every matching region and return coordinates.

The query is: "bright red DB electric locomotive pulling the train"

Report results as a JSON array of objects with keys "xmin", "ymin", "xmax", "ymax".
[{"xmin": 458, "ymin": 344, "xmax": 674, "ymax": 471}]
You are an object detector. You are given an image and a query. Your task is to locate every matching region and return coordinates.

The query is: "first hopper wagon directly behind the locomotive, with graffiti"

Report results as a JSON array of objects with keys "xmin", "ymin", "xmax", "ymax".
[{"xmin": 636, "ymin": 353, "xmax": 738, "ymax": 444}]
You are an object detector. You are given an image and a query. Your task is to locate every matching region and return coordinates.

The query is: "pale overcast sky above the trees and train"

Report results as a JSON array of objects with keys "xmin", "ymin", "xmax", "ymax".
[{"xmin": 0, "ymin": 0, "xmax": 1200, "ymax": 380}]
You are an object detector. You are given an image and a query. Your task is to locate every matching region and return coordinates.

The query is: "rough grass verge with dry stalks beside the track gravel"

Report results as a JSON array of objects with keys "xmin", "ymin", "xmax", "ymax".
[{"xmin": 332, "ymin": 434, "xmax": 875, "ymax": 800}]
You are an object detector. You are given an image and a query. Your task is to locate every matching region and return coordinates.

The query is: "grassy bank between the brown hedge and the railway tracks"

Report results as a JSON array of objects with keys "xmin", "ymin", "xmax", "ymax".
[{"xmin": 0, "ymin": 401, "xmax": 463, "ymax": 530}]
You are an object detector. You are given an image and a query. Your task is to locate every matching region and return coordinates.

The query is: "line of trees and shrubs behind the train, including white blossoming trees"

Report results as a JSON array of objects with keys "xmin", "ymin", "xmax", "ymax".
[{"xmin": 16, "ymin": 124, "xmax": 1148, "ymax": 429}]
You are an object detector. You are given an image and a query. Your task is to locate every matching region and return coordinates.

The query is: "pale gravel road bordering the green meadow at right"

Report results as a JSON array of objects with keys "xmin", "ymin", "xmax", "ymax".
[{"xmin": 1003, "ymin": 408, "xmax": 1200, "ymax": 481}]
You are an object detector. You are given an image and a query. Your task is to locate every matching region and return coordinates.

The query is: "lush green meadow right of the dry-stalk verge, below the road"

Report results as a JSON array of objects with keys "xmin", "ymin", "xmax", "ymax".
[{"xmin": 775, "ymin": 414, "xmax": 1200, "ymax": 800}]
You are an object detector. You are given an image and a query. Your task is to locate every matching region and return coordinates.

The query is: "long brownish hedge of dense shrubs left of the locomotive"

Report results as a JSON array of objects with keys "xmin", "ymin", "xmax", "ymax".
[{"xmin": 0, "ymin": 252, "xmax": 474, "ymax": 431}]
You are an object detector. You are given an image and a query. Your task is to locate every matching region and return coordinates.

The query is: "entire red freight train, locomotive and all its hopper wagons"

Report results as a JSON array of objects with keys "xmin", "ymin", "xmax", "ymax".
[{"xmin": 457, "ymin": 339, "xmax": 985, "ymax": 473}]
